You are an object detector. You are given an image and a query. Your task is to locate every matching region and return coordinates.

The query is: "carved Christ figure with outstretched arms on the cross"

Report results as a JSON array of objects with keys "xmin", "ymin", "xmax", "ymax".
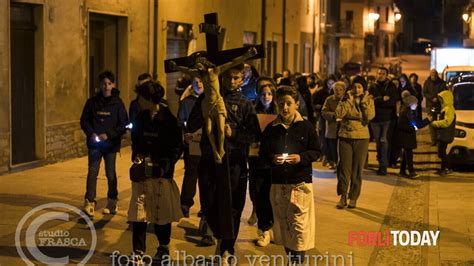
[{"xmin": 170, "ymin": 47, "xmax": 257, "ymax": 164}]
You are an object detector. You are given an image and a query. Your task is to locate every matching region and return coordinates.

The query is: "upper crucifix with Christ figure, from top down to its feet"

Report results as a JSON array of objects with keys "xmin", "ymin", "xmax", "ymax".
[{"xmin": 165, "ymin": 13, "xmax": 263, "ymax": 164}]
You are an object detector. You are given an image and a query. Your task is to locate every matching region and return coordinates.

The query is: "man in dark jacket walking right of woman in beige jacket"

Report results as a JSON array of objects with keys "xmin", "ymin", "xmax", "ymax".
[{"xmin": 369, "ymin": 67, "xmax": 399, "ymax": 175}]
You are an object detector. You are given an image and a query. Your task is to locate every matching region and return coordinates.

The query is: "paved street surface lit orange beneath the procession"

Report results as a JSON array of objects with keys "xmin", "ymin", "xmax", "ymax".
[{"xmin": 0, "ymin": 132, "xmax": 474, "ymax": 265}]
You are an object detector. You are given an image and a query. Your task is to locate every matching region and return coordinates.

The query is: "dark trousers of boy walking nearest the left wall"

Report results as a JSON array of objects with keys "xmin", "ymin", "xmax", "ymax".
[{"xmin": 84, "ymin": 149, "xmax": 118, "ymax": 202}]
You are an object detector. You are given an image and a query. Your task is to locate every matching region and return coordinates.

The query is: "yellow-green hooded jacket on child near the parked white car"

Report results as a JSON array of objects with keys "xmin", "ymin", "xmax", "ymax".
[{"xmin": 431, "ymin": 90, "xmax": 456, "ymax": 143}]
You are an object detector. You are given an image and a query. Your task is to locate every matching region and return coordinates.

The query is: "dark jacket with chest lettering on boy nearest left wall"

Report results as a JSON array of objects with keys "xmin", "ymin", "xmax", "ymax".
[{"xmin": 80, "ymin": 90, "xmax": 128, "ymax": 152}]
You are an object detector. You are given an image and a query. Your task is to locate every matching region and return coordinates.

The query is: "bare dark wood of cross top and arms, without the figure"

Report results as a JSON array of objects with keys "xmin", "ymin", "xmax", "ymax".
[{"xmin": 165, "ymin": 13, "xmax": 265, "ymax": 73}]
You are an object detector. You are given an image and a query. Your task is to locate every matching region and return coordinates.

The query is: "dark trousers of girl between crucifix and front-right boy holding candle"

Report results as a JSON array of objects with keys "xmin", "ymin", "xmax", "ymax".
[{"xmin": 249, "ymin": 157, "xmax": 273, "ymax": 231}]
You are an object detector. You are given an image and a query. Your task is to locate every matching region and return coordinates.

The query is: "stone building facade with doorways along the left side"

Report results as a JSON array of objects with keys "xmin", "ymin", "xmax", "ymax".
[{"xmin": 0, "ymin": 0, "xmax": 320, "ymax": 173}]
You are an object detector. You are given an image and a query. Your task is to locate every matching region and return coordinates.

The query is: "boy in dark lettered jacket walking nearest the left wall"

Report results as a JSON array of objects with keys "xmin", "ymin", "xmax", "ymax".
[{"xmin": 81, "ymin": 71, "xmax": 128, "ymax": 217}]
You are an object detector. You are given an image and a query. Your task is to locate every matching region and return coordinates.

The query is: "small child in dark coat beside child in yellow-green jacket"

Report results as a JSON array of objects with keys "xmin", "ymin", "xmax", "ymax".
[{"xmin": 395, "ymin": 90, "xmax": 430, "ymax": 179}]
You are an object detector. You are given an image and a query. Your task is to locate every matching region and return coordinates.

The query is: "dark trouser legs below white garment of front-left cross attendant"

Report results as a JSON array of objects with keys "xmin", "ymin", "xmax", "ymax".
[{"xmin": 132, "ymin": 222, "xmax": 171, "ymax": 253}]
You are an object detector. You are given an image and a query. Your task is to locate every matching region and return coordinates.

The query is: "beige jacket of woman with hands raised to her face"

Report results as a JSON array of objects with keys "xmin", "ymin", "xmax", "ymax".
[{"xmin": 336, "ymin": 97, "xmax": 375, "ymax": 139}]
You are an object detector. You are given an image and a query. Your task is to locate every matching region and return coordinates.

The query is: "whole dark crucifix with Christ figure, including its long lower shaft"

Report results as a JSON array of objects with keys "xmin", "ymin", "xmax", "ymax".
[{"xmin": 165, "ymin": 13, "xmax": 264, "ymax": 239}]
